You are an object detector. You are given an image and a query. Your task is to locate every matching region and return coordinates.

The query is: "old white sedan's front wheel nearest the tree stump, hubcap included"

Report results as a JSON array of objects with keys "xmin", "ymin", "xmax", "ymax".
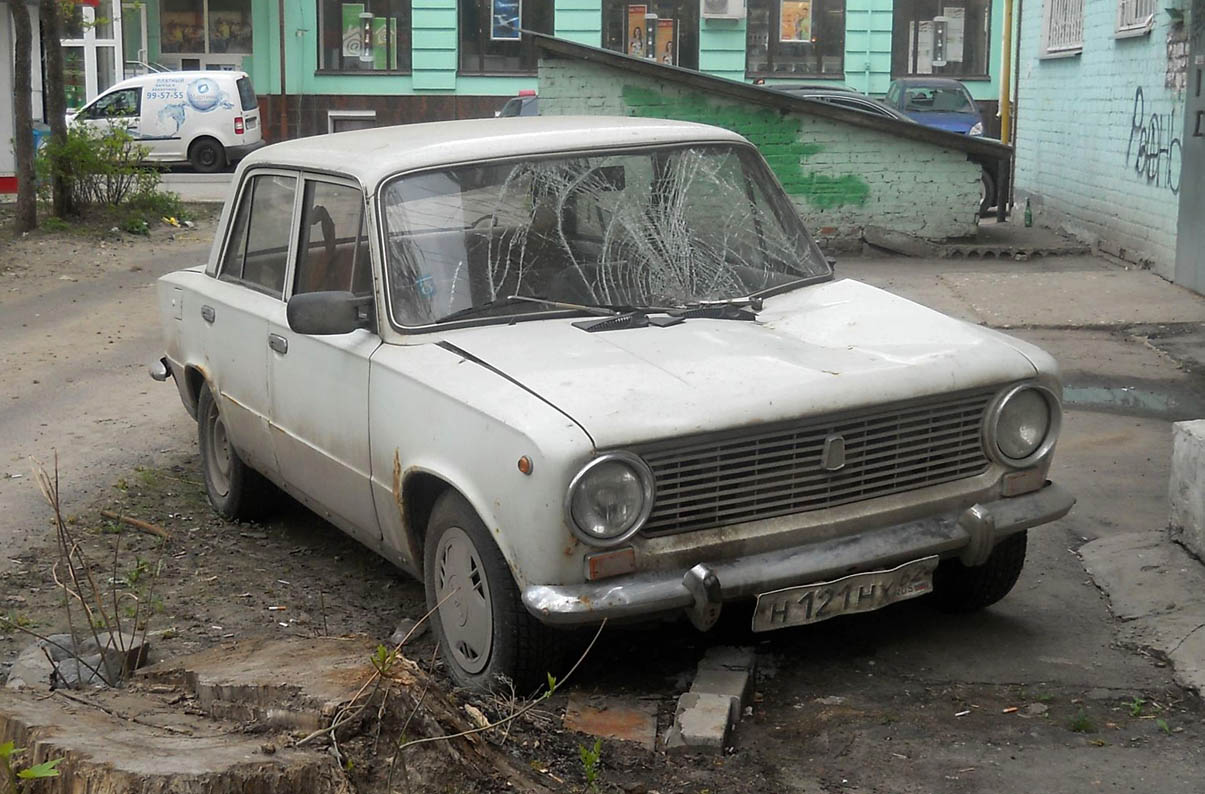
[{"xmin": 423, "ymin": 490, "xmax": 560, "ymax": 695}]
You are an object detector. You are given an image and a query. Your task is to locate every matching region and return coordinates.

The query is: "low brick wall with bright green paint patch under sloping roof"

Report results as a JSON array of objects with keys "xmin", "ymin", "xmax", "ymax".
[{"xmin": 540, "ymin": 58, "xmax": 981, "ymax": 248}]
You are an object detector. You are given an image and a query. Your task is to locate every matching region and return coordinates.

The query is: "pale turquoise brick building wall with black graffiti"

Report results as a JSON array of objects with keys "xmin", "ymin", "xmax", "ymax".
[{"xmin": 1016, "ymin": 0, "xmax": 1205, "ymax": 289}]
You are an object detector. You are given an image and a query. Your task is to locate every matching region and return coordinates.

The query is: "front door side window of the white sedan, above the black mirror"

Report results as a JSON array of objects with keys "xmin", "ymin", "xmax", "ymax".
[{"xmin": 293, "ymin": 181, "xmax": 372, "ymax": 295}]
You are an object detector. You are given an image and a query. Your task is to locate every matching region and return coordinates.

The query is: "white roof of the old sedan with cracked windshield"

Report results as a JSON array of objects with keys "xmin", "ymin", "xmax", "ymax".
[{"xmin": 240, "ymin": 116, "xmax": 745, "ymax": 189}]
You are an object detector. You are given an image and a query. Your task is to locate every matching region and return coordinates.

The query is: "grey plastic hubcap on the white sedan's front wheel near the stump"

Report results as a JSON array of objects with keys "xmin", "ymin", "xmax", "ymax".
[{"xmin": 435, "ymin": 527, "xmax": 494, "ymax": 675}]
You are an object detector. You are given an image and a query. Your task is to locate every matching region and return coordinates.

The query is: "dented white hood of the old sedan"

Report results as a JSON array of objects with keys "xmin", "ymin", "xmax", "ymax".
[{"xmin": 445, "ymin": 280, "xmax": 1036, "ymax": 448}]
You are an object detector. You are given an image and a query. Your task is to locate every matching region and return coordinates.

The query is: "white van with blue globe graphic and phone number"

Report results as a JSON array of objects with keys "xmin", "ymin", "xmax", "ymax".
[{"xmin": 67, "ymin": 71, "xmax": 264, "ymax": 173}]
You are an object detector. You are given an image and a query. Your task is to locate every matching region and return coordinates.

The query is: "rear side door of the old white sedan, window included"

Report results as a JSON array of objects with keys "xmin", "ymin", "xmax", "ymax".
[{"xmin": 200, "ymin": 171, "xmax": 300, "ymax": 475}]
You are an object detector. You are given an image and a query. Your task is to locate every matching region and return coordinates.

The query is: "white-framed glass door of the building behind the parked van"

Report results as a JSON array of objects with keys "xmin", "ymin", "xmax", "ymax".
[{"xmin": 63, "ymin": 0, "xmax": 124, "ymax": 108}]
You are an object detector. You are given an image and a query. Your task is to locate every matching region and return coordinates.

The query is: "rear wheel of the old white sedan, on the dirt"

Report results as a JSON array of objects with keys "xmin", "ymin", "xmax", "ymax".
[{"xmin": 196, "ymin": 384, "xmax": 276, "ymax": 520}]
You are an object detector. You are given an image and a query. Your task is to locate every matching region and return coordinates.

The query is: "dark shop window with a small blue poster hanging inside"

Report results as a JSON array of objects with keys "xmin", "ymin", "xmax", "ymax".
[{"xmin": 460, "ymin": 0, "xmax": 553, "ymax": 75}]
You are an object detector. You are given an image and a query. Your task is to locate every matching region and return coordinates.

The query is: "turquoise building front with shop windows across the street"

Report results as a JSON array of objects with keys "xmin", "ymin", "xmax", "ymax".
[{"xmin": 21, "ymin": 0, "xmax": 1017, "ymax": 136}]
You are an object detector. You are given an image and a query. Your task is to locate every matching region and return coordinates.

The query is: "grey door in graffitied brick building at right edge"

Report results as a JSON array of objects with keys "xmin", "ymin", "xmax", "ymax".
[{"xmin": 1176, "ymin": 6, "xmax": 1205, "ymax": 293}]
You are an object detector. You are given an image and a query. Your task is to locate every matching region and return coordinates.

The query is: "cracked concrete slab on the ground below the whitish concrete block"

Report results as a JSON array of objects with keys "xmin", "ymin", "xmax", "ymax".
[{"xmin": 1078, "ymin": 531, "xmax": 1205, "ymax": 694}]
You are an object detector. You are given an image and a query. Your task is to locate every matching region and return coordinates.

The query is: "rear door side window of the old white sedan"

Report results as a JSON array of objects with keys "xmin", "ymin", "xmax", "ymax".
[{"xmin": 218, "ymin": 173, "xmax": 296, "ymax": 298}]
